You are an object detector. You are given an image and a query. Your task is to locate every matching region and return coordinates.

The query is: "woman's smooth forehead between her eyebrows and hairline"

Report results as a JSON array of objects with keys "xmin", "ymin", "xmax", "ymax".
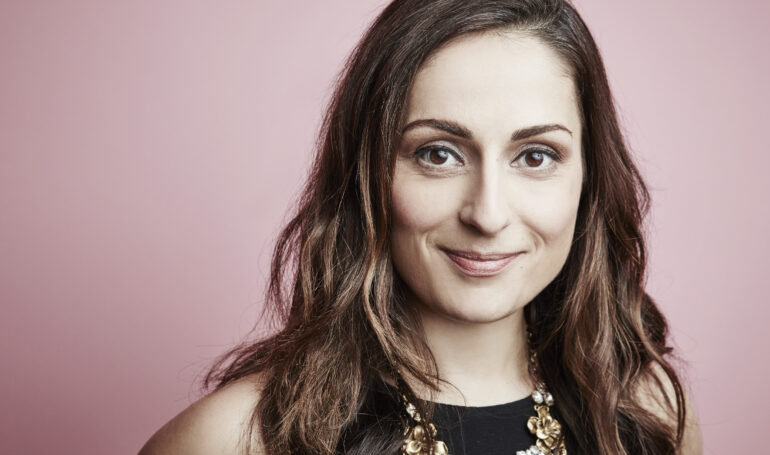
[{"xmin": 406, "ymin": 32, "xmax": 580, "ymax": 135}]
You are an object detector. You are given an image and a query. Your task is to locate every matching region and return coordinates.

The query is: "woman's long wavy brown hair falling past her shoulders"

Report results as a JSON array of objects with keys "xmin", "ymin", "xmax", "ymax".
[{"xmin": 205, "ymin": 0, "xmax": 685, "ymax": 455}]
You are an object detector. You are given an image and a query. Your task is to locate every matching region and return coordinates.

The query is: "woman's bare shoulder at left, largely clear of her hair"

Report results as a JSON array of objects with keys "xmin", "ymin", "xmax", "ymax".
[{"xmin": 139, "ymin": 375, "xmax": 262, "ymax": 455}]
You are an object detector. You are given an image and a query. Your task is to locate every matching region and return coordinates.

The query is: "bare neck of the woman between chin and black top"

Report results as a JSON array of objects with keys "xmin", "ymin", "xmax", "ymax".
[{"xmin": 410, "ymin": 302, "xmax": 534, "ymax": 406}]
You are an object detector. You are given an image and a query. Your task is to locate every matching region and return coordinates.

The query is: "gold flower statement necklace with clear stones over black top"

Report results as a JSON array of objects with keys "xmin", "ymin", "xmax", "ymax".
[{"xmin": 399, "ymin": 333, "xmax": 567, "ymax": 455}]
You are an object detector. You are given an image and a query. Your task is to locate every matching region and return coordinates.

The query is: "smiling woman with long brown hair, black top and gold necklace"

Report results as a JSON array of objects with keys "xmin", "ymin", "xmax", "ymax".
[{"xmin": 142, "ymin": 0, "xmax": 700, "ymax": 454}]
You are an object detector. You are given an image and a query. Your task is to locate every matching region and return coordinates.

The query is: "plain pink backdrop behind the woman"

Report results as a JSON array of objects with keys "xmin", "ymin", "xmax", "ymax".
[{"xmin": 0, "ymin": 0, "xmax": 770, "ymax": 454}]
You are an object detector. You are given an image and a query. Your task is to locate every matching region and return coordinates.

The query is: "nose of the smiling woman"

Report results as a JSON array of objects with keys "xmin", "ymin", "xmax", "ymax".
[{"xmin": 460, "ymin": 165, "xmax": 512, "ymax": 236}]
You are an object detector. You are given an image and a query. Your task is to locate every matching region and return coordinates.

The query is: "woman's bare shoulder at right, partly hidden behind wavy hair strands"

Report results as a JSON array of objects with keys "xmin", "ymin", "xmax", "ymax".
[{"xmin": 637, "ymin": 363, "xmax": 703, "ymax": 455}]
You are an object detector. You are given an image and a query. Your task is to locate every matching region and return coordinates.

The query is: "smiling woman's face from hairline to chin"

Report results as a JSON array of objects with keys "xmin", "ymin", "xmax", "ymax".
[{"xmin": 391, "ymin": 33, "xmax": 583, "ymax": 322}]
